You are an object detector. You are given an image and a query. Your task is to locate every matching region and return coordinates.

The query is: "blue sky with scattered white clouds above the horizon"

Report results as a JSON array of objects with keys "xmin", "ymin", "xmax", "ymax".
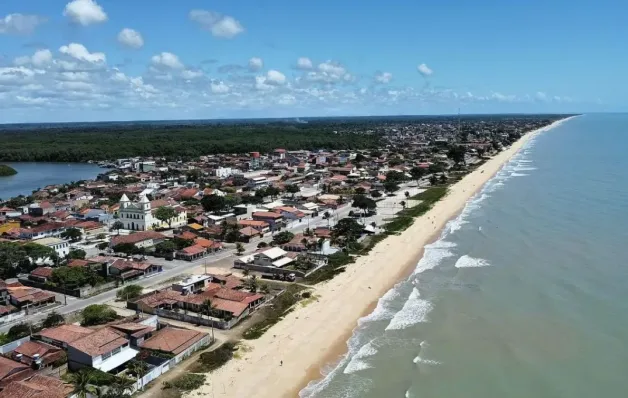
[{"xmin": 0, "ymin": 0, "xmax": 628, "ymax": 123}]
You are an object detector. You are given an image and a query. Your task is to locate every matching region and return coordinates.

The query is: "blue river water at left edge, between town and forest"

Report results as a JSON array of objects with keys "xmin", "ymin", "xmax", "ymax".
[{"xmin": 0, "ymin": 162, "xmax": 106, "ymax": 200}]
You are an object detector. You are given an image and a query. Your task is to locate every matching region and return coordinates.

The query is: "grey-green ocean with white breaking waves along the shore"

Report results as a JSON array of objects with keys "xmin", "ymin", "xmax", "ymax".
[{"xmin": 300, "ymin": 114, "xmax": 628, "ymax": 398}]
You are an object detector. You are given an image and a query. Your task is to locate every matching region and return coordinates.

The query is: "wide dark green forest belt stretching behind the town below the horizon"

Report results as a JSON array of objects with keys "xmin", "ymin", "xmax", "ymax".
[{"xmin": 0, "ymin": 123, "xmax": 381, "ymax": 162}]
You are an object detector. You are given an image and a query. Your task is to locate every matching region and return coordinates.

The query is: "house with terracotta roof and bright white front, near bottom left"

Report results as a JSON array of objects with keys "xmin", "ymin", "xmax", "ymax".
[{"xmin": 68, "ymin": 327, "xmax": 139, "ymax": 372}]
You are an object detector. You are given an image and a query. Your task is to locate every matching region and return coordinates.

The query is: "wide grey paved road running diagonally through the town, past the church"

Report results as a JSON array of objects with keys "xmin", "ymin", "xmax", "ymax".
[{"xmin": 0, "ymin": 185, "xmax": 423, "ymax": 333}]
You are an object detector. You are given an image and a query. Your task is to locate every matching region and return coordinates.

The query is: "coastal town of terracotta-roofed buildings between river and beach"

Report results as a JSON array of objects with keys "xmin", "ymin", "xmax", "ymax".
[{"xmin": 0, "ymin": 115, "xmax": 563, "ymax": 398}]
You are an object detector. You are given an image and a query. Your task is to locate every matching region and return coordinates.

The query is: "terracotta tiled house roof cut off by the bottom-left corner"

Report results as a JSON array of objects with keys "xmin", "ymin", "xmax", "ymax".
[{"xmin": 0, "ymin": 374, "xmax": 74, "ymax": 398}]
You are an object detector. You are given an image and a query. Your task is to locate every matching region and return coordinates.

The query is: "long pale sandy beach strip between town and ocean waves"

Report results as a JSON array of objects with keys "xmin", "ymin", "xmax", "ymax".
[{"xmin": 191, "ymin": 119, "xmax": 567, "ymax": 398}]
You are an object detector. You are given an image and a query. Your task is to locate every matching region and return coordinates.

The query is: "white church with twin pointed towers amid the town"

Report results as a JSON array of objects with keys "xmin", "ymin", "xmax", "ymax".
[{"xmin": 118, "ymin": 195, "xmax": 188, "ymax": 231}]
